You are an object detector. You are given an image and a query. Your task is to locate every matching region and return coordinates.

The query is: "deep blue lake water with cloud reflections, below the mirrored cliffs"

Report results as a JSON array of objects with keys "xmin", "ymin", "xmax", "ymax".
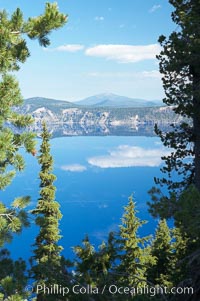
[{"xmin": 0, "ymin": 136, "xmax": 166, "ymax": 259}]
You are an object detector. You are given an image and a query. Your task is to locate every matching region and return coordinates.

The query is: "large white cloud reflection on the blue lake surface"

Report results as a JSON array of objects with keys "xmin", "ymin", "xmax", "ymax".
[{"xmin": 88, "ymin": 145, "xmax": 169, "ymax": 168}]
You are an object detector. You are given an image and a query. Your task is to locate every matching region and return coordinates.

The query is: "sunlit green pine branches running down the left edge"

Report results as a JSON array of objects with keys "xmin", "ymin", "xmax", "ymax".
[{"xmin": 0, "ymin": 3, "xmax": 67, "ymax": 239}]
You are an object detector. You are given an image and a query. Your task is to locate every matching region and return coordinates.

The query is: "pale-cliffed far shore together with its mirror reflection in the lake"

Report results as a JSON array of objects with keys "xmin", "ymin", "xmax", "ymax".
[{"xmin": 16, "ymin": 96, "xmax": 184, "ymax": 136}]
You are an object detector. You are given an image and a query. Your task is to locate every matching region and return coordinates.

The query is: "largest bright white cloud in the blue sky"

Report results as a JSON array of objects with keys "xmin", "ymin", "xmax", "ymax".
[{"xmin": 85, "ymin": 44, "xmax": 160, "ymax": 63}]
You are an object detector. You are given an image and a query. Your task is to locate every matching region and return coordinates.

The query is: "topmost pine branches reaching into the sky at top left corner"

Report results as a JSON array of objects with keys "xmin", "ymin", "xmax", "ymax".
[{"xmin": 0, "ymin": 3, "xmax": 67, "ymax": 72}]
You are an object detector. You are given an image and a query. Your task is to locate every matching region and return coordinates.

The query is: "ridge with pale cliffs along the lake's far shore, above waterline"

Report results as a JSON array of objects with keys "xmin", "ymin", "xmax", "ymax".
[{"xmin": 20, "ymin": 97, "xmax": 183, "ymax": 126}]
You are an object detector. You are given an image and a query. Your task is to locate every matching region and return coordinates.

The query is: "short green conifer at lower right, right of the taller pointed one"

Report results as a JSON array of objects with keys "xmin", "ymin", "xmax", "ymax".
[{"xmin": 147, "ymin": 219, "xmax": 190, "ymax": 300}]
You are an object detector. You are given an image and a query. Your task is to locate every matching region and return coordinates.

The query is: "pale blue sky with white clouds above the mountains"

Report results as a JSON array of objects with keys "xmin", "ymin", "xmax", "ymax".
[{"xmin": 0, "ymin": 0, "xmax": 176, "ymax": 101}]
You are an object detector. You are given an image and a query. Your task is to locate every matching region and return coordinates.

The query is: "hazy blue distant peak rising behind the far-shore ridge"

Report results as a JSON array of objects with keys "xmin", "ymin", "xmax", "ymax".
[{"xmin": 75, "ymin": 93, "xmax": 163, "ymax": 108}]
